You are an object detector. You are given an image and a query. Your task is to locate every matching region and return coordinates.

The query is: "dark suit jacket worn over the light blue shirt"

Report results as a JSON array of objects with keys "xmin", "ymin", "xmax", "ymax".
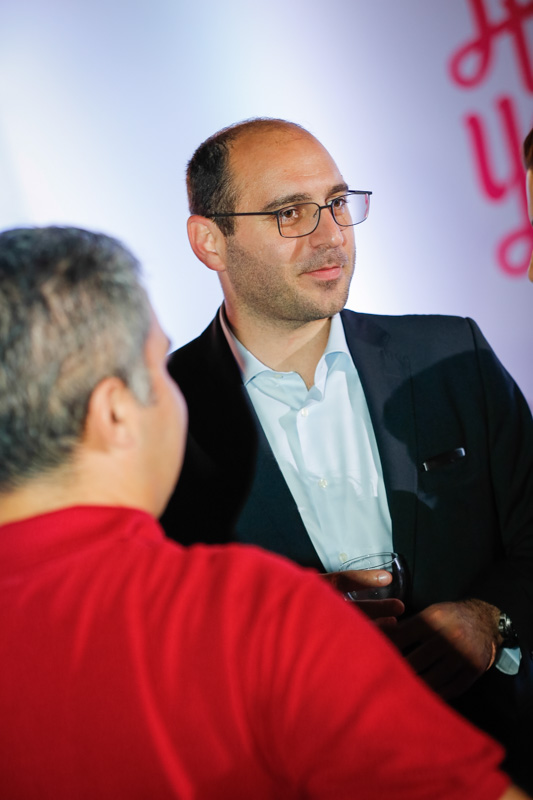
[{"xmin": 162, "ymin": 311, "xmax": 533, "ymax": 776}]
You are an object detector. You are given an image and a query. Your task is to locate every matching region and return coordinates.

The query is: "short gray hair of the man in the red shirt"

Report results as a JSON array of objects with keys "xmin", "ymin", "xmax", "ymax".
[{"xmin": 0, "ymin": 227, "xmax": 151, "ymax": 492}]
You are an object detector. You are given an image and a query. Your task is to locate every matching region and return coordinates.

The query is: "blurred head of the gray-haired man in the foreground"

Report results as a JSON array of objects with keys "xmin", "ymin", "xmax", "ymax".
[{"xmin": 0, "ymin": 227, "xmax": 184, "ymax": 513}]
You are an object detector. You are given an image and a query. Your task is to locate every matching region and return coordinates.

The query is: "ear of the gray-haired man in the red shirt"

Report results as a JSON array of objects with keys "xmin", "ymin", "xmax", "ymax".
[{"xmin": 84, "ymin": 376, "xmax": 137, "ymax": 451}]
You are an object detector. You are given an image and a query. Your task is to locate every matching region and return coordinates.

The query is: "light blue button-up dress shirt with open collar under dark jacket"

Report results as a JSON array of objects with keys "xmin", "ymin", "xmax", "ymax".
[{"xmin": 221, "ymin": 313, "xmax": 392, "ymax": 571}]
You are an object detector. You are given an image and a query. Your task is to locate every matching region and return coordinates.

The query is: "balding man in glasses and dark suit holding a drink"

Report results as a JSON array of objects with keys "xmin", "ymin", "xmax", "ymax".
[{"xmin": 162, "ymin": 119, "xmax": 533, "ymax": 783}]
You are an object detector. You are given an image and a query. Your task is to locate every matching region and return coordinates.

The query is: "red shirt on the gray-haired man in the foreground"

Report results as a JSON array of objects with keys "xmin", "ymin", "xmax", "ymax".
[{"xmin": 0, "ymin": 507, "xmax": 509, "ymax": 800}]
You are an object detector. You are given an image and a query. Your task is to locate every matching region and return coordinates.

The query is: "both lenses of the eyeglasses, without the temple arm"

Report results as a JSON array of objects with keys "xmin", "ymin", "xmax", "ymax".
[{"xmin": 278, "ymin": 192, "xmax": 370, "ymax": 239}]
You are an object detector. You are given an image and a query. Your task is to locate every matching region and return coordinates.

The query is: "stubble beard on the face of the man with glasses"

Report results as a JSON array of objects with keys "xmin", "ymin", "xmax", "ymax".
[{"xmin": 222, "ymin": 237, "xmax": 355, "ymax": 327}]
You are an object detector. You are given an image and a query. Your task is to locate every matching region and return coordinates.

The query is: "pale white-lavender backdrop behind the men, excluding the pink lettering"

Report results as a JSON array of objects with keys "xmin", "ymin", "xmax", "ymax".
[{"xmin": 0, "ymin": 0, "xmax": 533, "ymax": 403}]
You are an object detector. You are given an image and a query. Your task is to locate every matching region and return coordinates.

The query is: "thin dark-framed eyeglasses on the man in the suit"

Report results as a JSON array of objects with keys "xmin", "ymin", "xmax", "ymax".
[{"xmin": 209, "ymin": 190, "xmax": 372, "ymax": 239}]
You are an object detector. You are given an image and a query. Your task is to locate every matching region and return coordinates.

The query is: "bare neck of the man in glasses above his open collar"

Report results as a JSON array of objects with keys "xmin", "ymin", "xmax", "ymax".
[{"xmin": 226, "ymin": 309, "xmax": 331, "ymax": 389}]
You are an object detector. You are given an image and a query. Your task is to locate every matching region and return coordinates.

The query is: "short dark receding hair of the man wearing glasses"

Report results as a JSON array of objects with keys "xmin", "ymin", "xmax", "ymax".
[{"xmin": 187, "ymin": 117, "xmax": 303, "ymax": 236}]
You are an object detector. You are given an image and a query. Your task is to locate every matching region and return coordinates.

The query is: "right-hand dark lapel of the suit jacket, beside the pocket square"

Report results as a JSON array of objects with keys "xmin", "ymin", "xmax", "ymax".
[{"xmin": 341, "ymin": 311, "xmax": 418, "ymax": 572}]
